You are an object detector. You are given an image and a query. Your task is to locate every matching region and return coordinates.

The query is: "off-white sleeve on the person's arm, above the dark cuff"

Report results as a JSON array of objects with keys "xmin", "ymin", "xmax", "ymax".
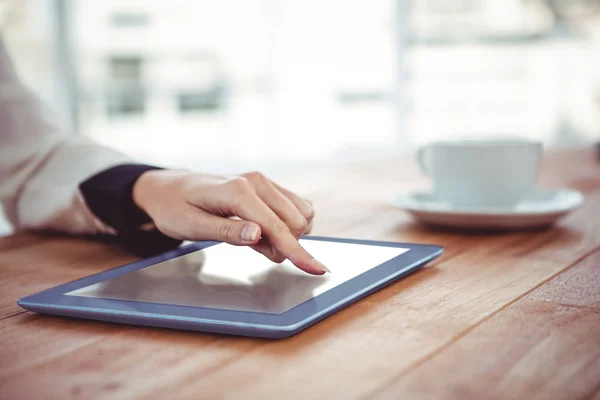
[{"xmin": 0, "ymin": 37, "xmax": 132, "ymax": 234}]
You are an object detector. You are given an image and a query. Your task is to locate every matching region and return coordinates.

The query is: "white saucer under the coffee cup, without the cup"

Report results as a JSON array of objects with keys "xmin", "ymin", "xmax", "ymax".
[{"xmin": 394, "ymin": 189, "xmax": 583, "ymax": 229}]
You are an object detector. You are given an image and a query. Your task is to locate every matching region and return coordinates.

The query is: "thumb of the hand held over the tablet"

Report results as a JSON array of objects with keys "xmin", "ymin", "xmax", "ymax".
[{"xmin": 197, "ymin": 215, "xmax": 261, "ymax": 246}]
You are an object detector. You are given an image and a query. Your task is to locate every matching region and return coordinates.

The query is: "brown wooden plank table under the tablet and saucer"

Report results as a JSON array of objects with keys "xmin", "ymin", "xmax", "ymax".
[{"xmin": 0, "ymin": 150, "xmax": 600, "ymax": 399}]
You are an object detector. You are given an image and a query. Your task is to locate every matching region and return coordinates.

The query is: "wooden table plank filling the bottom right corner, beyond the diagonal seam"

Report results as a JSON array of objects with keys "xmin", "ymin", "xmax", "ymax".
[{"xmin": 377, "ymin": 252, "xmax": 600, "ymax": 400}]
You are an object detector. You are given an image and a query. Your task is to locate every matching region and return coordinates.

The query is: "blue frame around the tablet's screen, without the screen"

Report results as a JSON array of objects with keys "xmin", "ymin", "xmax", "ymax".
[{"xmin": 18, "ymin": 236, "xmax": 443, "ymax": 337}]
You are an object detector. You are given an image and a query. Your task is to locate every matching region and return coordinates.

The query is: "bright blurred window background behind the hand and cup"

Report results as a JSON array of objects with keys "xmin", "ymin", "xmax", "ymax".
[{"xmin": 0, "ymin": 0, "xmax": 600, "ymax": 175}]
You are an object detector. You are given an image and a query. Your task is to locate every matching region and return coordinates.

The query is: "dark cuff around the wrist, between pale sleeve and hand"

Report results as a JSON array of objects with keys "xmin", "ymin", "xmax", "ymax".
[{"xmin": 79, "ymin": 164, "xmax": 182, "ymax": 257}]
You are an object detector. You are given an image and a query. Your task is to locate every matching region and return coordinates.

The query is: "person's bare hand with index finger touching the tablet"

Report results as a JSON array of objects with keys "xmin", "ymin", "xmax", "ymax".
[{"xmin": 133, "ymin": 170, "xmax": 329, "ymax": 275}]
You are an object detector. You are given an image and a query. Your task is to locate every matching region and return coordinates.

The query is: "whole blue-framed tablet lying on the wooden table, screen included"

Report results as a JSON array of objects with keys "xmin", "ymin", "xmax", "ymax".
[{"xmin": 18, "ymin": 237, "xmax": 442, "ymax": 338}]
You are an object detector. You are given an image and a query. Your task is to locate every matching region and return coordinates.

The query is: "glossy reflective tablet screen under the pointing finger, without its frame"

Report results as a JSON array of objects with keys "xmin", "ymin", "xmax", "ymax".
[{"xmin": 65, "ymin": 239, "xmax": 408, "ymax": 314}]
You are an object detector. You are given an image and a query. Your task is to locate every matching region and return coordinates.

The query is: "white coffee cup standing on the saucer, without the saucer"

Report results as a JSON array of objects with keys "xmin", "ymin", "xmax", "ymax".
[{"xmin": 418, "ymin": 139, "xmax": 542, "ymax": 208}]
